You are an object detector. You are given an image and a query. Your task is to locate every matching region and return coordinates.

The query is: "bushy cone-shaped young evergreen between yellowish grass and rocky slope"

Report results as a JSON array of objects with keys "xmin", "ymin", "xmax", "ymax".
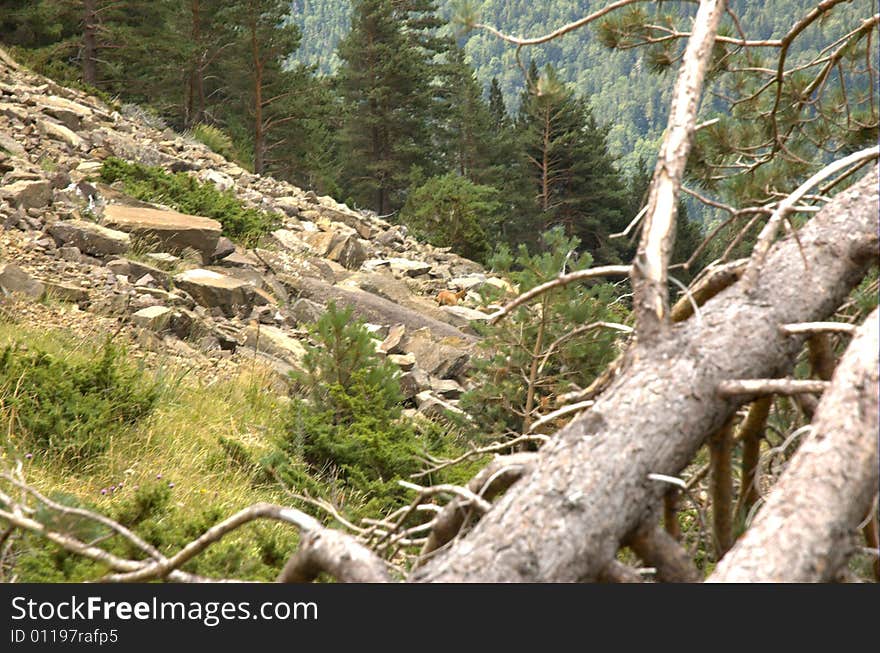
[{"xmin": 264, "ymin": 304, "xmax": 427, "ymax": 511}]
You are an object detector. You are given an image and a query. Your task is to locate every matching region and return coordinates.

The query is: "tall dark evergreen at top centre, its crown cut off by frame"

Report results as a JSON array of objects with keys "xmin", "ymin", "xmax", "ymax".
[{"xmin": 338, "ymin": 0, "xmax": 446, "ymax": 214}]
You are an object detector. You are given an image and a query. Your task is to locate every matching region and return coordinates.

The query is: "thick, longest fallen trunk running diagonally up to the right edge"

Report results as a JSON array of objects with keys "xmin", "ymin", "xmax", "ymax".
[{"xmin": 412, "ymin": 167, "xmax": 878, "ymax": 582}]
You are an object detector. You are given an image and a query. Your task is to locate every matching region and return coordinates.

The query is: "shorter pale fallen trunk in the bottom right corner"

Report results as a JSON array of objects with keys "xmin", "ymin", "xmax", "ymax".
[{"xmin": 709, "ymin": 309, "xmax": 880, "ymax": 583}]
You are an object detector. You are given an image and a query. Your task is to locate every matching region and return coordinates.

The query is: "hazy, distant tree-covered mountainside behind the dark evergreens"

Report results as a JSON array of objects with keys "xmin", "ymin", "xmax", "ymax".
[{"xmin": 291, "ymin": 0, "xmax": 871, "ymax": 171}]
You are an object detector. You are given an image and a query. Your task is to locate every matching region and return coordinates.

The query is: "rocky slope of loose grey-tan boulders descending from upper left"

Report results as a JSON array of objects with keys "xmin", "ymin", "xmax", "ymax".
[{"xmin": 0, "ymin": 50, "xmax": 506, "ymax": 414}]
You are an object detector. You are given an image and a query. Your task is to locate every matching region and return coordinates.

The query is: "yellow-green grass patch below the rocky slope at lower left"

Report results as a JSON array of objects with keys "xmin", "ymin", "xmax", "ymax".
[{"xmin": 0, "ymin": 322, "xmax": 297, "ymax": 582}]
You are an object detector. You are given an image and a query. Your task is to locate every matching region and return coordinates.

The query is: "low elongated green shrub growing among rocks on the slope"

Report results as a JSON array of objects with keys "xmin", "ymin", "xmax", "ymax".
[{"xmin": 101, "ymin": 157, "xmax": 280, "ymax": 243}]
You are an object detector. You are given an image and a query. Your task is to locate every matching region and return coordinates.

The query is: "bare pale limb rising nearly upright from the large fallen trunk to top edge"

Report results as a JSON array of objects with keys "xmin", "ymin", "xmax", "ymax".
[{"xmin": 630, "ymin": 0, "xmax": 725, "ymax": 342}]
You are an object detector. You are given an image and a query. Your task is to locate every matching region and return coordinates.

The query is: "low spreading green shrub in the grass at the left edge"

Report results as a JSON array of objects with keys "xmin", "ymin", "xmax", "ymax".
[{"xmin": 0, "ymin": 343, "xmax": 159, "ymax": 464}]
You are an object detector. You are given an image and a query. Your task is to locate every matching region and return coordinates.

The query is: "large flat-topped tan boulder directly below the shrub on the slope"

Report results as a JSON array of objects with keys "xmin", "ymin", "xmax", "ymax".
[{"xmin": 104, "ymin": 204, "xmax": 223, "ymax": 260}]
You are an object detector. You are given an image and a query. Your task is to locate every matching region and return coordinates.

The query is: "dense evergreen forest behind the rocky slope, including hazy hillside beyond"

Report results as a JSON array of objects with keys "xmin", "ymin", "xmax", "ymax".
[{"xmin": 0, "ymin": 0, "xmax": 876, "ymax": 263}]
